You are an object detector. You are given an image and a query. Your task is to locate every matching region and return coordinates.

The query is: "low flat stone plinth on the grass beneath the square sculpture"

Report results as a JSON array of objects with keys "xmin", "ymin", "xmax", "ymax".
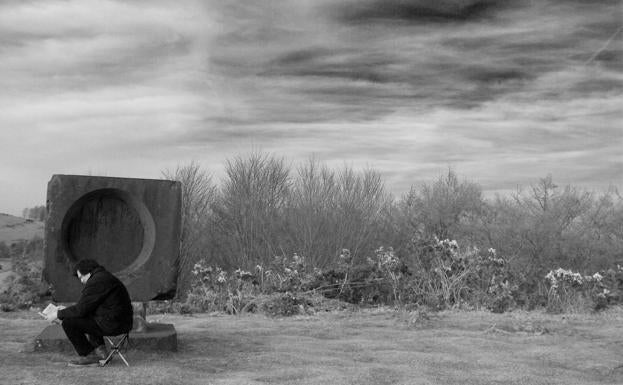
[{"xmin": 34, "ymin": 322, "xmax": 177, "ymax": 353}]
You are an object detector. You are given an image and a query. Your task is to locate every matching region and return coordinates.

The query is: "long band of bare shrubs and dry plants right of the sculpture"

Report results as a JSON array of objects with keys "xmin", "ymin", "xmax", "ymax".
[{"xmin": 164, "ymin": 153, "xmax": 623, "ymax": 312}]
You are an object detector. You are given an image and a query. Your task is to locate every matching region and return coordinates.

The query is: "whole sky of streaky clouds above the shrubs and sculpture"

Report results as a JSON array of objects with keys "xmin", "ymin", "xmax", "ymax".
[{"xmin": 0, "ymin": 0, "xmax": 623, "ymax": 215}]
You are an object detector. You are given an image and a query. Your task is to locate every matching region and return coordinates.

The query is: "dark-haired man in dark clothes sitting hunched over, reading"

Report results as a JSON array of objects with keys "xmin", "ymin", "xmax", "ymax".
[{"xmin": 47, "ymin": 259, "xmax": 132, "ymax": 366}]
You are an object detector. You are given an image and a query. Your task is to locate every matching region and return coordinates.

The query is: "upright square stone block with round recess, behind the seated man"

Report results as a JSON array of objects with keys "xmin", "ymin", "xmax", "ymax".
[{"xmin": 43, "ymin": 175, "xmax": 181, "ymax": 302}]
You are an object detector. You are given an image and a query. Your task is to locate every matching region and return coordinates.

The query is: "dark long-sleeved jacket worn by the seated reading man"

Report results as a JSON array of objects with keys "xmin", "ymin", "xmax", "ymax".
[{"xmin": 57, "ymin": 266, "xmax": 132, "ymax": 335}]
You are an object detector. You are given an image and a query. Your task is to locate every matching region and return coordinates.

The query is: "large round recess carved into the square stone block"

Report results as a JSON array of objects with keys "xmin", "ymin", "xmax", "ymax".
[{"xmin": 61, "ymin": 189, "xmax": 155, "ymax": 275}]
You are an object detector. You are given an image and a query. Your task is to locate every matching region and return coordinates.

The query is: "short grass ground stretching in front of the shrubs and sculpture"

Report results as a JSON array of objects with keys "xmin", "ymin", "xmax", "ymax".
[{"xmin": 0, "ymin": 309, "xmax": 623, "ymax": 385}]
